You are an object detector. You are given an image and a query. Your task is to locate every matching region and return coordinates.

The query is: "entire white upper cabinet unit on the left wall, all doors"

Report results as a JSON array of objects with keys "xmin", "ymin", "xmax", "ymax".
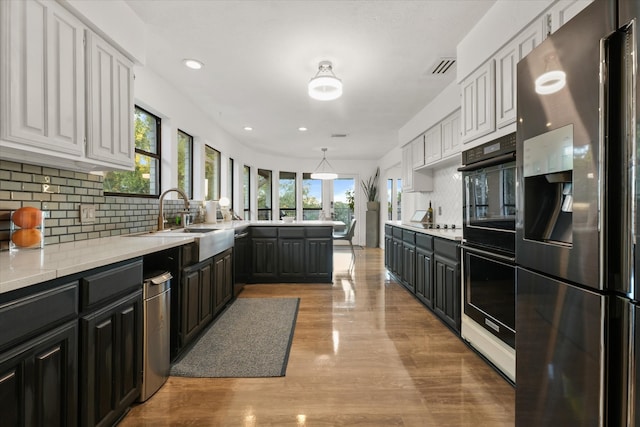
[{"xmin": 0, "ymin": 0, "xmax": 135, "ymax": 171}]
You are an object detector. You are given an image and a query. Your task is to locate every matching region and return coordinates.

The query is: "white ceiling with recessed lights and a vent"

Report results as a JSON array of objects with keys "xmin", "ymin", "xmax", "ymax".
[{"xmin": 127, "ymin": 0, "xmax": 495, "ymax": 160}]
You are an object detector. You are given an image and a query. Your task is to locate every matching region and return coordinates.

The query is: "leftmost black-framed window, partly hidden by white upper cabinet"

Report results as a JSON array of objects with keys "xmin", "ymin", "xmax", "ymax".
[{"xmin": 103, "ymin": 106, "xmax": 160, "ymax": 197}]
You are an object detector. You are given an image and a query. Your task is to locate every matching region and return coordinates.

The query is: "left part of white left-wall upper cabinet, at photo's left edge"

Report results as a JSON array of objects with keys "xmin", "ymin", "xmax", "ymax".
[{"xmin": 0, "ymin": 0, "xmax": 85, "ymax": 158}]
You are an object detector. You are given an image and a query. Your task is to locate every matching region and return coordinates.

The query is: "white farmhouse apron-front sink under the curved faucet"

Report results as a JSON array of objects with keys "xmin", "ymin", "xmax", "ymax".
[{"xmin": 130, "ymin": 227, "xmax": 234, "ymax": 261}]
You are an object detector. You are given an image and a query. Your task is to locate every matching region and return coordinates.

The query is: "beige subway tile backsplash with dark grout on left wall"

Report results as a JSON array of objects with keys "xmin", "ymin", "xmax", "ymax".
[{"xmin": 0, "ymin": 160, "xmax": 202, "ymax": 250}]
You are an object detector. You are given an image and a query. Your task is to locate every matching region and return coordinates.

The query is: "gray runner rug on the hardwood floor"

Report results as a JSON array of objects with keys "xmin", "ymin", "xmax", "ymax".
[{"xmin": 171, "ymin": 298, "xmax": 300, "ymax": 378}]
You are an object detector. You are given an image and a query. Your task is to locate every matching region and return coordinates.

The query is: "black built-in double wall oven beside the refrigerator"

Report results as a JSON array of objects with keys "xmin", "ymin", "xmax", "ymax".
[{"xmin": 459, "ymin": 133, "xmax": 516, "ymax": 348}]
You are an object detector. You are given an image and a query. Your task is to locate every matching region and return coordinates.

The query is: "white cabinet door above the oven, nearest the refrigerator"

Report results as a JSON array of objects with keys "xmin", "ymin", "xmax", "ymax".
[{"xmin": 495, "ymin": 21, "xmax": 543, "ymax": 128}]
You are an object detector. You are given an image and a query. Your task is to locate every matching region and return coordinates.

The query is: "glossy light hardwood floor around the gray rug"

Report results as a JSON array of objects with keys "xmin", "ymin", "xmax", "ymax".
[{"xmin": 120, "ymin": 248, "xmax": 515, "ymax": 427}]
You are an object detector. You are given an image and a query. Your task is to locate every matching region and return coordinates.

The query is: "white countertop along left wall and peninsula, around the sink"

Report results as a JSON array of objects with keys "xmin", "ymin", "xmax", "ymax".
[{"xmin": 0, "ymin": 221, "xmax": 342, "ymax": 294}]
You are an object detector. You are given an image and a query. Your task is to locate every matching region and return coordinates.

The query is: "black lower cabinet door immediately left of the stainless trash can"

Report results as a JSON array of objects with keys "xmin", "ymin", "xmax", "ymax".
[{"xmin": 80, "ymin": 290, "xmax": 142, "ymax": 426}]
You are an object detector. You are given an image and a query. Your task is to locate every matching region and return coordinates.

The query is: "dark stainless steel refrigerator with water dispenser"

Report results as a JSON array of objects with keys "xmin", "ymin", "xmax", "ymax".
[{"xmin": 516, "ymin": 0, "xmax": 640, "ymax": 426}]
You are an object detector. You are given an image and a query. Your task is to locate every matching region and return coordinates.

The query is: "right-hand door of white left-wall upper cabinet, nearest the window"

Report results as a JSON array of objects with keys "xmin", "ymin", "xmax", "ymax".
[{"xmin": 87, "ymin": 32, "xmax": 135, "ymax": 169}]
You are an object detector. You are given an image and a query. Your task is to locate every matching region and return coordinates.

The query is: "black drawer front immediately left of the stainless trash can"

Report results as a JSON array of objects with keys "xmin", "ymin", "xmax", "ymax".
[{"xmin": 80, "ymin": 260, "xmax": 142, "ymax": 310}]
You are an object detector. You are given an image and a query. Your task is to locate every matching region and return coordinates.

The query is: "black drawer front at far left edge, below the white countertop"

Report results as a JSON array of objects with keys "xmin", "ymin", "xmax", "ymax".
[{"xmin": 0, "ymin": 282, "xmax": 78, "ymax": 348}]
